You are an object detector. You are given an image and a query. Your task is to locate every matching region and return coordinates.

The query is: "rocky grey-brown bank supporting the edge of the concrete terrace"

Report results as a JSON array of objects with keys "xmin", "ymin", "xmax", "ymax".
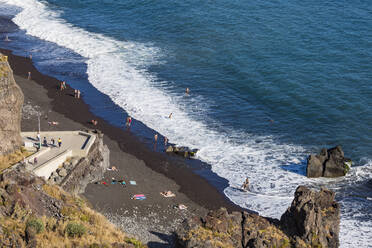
[{"xmin": 58, "ymin": 132, "xmax": 110, "ymax": 194}]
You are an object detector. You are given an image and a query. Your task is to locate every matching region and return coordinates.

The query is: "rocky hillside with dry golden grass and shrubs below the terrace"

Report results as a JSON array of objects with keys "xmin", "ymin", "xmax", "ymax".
[{"xmin": 0, "ymin": 169, "xmax": 145, "ymax": 247}]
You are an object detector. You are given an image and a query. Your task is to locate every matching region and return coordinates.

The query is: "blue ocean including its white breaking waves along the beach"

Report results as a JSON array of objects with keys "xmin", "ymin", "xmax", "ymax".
[{"xmin": 0, "ymin": 0, "xmax": 372, "ymax": 247}]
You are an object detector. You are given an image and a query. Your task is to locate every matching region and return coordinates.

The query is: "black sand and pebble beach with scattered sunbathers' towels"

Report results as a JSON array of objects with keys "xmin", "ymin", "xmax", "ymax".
[{"xmin": 0, "ymin": 49, "xmax": 241, "ymax": 247}]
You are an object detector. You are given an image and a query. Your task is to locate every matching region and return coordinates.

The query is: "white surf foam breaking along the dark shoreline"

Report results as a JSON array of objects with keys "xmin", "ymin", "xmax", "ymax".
[{"xmin": 0, "ymin": 0, "xmax": 372, "ymax": 247}]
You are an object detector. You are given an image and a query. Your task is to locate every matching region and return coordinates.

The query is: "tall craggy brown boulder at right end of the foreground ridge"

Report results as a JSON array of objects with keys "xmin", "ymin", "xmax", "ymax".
[{"xmin": 280, "ymin": 186, "xmax": 340, "ymax": 247}]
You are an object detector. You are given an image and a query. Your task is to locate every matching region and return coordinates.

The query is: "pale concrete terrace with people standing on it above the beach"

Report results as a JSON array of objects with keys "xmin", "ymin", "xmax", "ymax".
[{"xmin": 21, "ymin": 131, "xmax": 96, "ymax": 179}]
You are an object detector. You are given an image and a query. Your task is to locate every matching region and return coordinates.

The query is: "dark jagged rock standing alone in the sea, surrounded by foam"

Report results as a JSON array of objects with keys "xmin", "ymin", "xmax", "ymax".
[{"xmin": 306, "ymin": 146, "xmax": 352, "ymax": 177}]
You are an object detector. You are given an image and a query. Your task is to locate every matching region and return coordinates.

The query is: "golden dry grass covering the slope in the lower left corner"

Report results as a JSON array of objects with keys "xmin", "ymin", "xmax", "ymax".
[{"xmin": 0, "ymin": 180, "xmax": 146, "ymax": 248}]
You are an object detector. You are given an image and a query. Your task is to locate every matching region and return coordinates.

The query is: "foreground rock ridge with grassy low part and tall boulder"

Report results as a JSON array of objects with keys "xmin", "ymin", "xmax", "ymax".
[{"xmin": 176, "ymin": 187, "xmax": 340, "ymax": 248}]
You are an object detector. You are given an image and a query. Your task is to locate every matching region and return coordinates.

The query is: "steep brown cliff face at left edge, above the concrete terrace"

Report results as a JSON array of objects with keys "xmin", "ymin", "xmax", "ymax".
[{"xmin": 0, "ymin": 54, "xmax": 24, "ymax": 155}]
